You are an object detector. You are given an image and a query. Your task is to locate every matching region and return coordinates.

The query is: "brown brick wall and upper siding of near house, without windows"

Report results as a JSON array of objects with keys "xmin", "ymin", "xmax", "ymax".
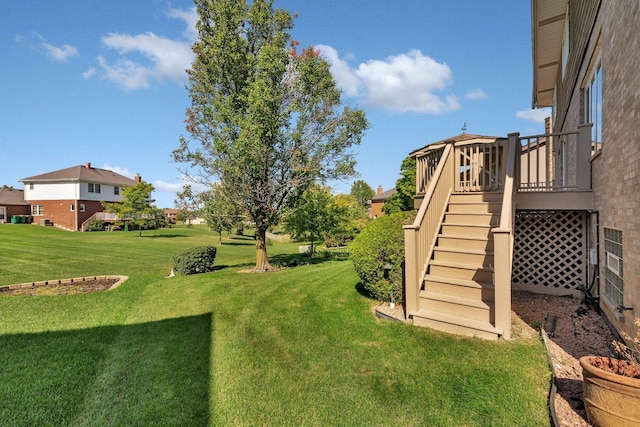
[{"xmin": 554, "ymin": 0, "xmax": 640, "ymax": 336}]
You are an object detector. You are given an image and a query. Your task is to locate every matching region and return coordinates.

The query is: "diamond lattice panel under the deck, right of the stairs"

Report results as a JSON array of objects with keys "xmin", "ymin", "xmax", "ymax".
[{"xmin": 512, "ymin": 211, "xmax": 587, "ymax": 294}]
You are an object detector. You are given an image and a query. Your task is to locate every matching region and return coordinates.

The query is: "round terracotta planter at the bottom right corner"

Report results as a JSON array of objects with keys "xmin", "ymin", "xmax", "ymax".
[{"xmin": 580, "ymin": 356, "xmax": 640, "ymax": 427}]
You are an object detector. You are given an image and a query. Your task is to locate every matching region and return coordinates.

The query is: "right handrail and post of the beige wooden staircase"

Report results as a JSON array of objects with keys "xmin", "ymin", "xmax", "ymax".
[{"xmin": 492, "ymin": 133, "xmax": 520, "ymax": 340}]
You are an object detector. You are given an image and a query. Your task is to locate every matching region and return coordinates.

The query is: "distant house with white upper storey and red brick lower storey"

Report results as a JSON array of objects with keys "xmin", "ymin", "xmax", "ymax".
[{"xmin": 20, "ymin": 163, "xmax": 140, "ymax": 231}]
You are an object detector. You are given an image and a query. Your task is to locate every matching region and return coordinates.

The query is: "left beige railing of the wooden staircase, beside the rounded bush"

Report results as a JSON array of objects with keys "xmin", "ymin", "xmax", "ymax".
[{"xmin": 404, "ymin": 145, "xmax": 455, "ymax": 314}]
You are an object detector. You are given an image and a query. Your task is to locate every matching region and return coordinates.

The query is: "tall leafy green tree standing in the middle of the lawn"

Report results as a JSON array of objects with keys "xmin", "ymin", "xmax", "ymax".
[{"xmin": 173, "ymin": 0, "xmax": 368, "ymax": 271}]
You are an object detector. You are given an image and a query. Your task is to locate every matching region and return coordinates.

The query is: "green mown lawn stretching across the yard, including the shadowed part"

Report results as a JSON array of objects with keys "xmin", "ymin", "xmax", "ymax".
[{"xmin": 0, "ymin": 224, "xmax": 550, "ymax": 426}]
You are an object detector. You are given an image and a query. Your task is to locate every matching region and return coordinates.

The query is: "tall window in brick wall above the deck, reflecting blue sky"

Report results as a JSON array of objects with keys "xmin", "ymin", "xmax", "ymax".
[{"xmin": 582, "ymin": 41, "xmax": 602, "ymax": 155}]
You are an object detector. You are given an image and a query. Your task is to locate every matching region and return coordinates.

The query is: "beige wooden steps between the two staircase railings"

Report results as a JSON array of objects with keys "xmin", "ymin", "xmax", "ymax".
[{"xmin": 409, "ymin": 192, "xmax": 502, "ymax": 339}]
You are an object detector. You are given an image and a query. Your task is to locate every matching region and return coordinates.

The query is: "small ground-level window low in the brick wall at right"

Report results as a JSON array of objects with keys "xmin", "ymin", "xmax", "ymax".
[{"xmin": 604, "ymin": 227, "xmax": 624, "ymax": 306}]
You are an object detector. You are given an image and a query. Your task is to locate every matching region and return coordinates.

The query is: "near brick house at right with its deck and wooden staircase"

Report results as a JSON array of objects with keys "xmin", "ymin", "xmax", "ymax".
[{"xmin": 405, "ymin": 0, "xmax": 640, "ymax": 339}]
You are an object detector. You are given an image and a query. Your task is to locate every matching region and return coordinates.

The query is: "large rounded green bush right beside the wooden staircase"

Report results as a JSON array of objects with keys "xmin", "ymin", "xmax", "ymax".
[{"xmin": 350, "ymin": 212, "xmax": 415, "ymax": 302}]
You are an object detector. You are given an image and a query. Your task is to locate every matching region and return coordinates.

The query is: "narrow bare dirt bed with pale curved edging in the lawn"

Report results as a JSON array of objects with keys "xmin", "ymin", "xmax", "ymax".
[{"xmin": 0, "ymin": 276, "xmax": 127, "ymax": 296}]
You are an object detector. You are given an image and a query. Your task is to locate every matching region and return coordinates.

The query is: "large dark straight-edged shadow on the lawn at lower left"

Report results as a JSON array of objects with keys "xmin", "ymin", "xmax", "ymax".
[{"xmin": 0, "ymin": 313, "xmax": 212, "ymax": 426}]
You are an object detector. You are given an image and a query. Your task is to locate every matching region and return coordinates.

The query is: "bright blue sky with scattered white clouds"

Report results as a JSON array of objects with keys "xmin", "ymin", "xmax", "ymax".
[{"xmin": 0, "ymin": 0, "xmax": 548, "ymax": 207}]
